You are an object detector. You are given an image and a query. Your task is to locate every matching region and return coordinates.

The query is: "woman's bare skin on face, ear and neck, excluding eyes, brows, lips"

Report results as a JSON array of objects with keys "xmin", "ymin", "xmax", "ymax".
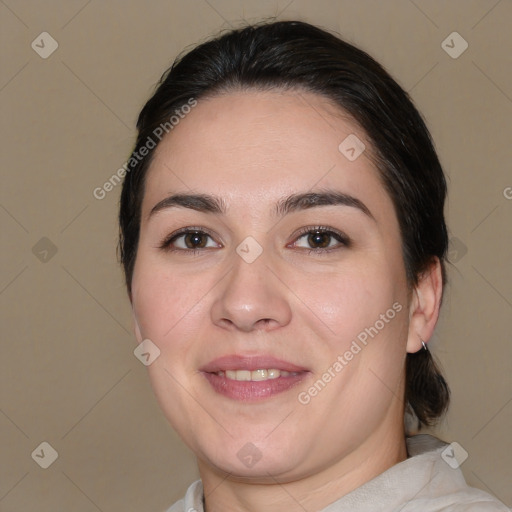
[{"xmin": 132, "ymin": 90, "xmax": 442, "ymax": 511}]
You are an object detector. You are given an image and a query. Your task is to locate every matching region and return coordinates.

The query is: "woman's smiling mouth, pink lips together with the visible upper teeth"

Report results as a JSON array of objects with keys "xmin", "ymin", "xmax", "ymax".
[{"xmin": 200, "ymin": 355, "xmax": 310, "ymax": 402}]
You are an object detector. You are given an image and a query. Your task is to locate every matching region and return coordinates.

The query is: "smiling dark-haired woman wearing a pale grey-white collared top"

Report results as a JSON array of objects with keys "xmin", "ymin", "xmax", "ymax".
[{"xmin": 120, "ymin": 22, "xmax": 506, "ymax": 512}]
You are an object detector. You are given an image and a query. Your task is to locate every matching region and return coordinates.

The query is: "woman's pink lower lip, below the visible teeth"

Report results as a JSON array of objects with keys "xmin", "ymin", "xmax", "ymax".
[{"xmin": 203, "ymin": 372, "xmax": 308, "ymax": 402}]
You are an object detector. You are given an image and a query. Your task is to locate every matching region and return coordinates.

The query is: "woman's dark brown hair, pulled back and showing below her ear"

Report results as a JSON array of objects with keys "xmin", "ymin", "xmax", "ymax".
[{"xmin": 119, "ymin": 21, "xmax": 449, "ymax": 427}]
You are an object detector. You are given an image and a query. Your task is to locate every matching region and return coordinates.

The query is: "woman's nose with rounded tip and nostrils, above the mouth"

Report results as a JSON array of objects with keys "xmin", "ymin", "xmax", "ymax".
[{"xmin": 211, "ymin": 255, "xmax": 292, "ymax": 332}]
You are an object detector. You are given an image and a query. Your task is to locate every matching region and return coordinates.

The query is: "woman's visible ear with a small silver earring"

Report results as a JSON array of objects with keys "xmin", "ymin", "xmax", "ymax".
[{"xmin": 407, "ymin": 256, "xmax": 443, "ymax": 353}]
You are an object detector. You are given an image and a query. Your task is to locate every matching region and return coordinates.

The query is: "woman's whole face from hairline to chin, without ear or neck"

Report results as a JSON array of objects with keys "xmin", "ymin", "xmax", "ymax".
[{"xmin": 132, "ymin": 91, "xmax": 409, "ymax": 481}]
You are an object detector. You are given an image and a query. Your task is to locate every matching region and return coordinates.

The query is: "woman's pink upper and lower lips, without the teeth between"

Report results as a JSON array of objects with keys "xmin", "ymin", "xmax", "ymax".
[{"xmin": 200, "ymin": 354, "xmax": 310, "ymax": 402}]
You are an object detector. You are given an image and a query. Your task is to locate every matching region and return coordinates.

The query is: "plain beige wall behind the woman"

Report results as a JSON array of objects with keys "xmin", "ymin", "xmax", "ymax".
[{"xmin": 0, "ymin": 0, "xmax": 512, "ymax": 512}]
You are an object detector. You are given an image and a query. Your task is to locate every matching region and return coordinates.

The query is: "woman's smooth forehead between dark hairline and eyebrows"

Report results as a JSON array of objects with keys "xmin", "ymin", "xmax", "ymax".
[{"xmin": 143, "ymin": 90, "xmax": 390, "ymax": 220}]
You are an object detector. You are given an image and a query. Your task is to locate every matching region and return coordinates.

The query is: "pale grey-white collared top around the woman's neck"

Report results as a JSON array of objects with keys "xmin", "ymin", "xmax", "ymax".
[{"xmin": 167, "ymin": 434, "xmax": 511, "ymax": 512}]
